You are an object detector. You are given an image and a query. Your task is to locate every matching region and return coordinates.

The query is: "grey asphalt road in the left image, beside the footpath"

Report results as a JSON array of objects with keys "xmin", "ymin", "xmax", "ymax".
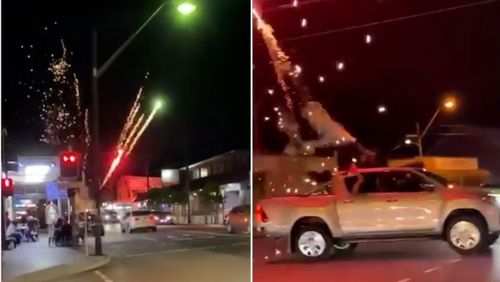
[{"xmin": 55, "ymin": 226, "xmax": 250, "ymax": 282}]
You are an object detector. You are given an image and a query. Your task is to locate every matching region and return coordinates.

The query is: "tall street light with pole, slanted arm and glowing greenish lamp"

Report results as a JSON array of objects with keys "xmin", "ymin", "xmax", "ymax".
[{"xmin": 90, "ymin": 2, "xmax": 196, "ymax": 256}]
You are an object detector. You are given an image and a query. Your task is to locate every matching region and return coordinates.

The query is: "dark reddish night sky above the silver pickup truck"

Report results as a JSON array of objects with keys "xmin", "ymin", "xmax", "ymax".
[{"xmin": 253, "ymin": 0, "xmax": 500, "ymax": 158}]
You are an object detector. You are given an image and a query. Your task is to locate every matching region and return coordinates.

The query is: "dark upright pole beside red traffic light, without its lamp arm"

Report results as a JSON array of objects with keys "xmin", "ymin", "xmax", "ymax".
[{"xmin": 91, "ymin": 30, "xmax": 102, "ymax": 256}]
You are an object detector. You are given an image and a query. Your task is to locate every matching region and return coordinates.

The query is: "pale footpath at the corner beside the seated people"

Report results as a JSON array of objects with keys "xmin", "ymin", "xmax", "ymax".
[{"xmin": 2, "ymin": 234, "xmax": 110, "ymax": 282}]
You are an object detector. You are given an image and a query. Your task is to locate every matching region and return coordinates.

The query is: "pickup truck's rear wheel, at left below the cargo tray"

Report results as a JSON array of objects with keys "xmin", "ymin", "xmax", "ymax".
[{"xmin": 295, "ymin": 226, "xmax": 333, "ymax": 260}]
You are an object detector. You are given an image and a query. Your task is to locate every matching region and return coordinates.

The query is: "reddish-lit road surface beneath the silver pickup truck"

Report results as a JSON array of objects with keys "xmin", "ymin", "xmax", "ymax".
[{"xmin": 253, "ymin": 239, "xmax": 500, "ymax": 282}]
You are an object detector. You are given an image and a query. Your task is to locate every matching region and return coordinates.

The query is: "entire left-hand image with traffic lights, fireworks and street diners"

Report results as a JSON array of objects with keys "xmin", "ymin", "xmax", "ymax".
[{"xmin": 1, "ymin": 0, "xmax": 251, "ymax": 282}]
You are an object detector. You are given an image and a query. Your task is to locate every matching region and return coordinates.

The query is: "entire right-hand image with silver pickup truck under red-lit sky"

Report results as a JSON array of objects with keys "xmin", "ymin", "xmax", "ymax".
[{"xmin": 252, "ymin": 0, "xmax": 500, "ymax": 282}]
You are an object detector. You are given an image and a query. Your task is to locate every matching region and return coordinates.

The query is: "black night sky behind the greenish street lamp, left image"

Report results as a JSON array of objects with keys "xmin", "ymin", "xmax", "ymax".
[{"xmin": 2, "ymin": 0, "xmax": 250, "ymax": 173}]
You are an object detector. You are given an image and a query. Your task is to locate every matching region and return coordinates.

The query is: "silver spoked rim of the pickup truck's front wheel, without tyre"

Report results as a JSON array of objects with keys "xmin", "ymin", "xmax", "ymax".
[{"xmin": 450, "ymin": 221, "xmax": 481, "ymax": 250}]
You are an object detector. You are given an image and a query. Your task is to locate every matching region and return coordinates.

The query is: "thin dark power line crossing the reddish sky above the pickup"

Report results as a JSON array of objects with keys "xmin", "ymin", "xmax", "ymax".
[{"xmin": 280, "ymin": 0, "xmax": 499, "ymax": 42}]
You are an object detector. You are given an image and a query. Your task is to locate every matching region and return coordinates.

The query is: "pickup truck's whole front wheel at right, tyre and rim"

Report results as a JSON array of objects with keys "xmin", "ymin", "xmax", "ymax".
[{"xmin": 446, "ymin": 215, "xmax": 490, "ymax": 255}]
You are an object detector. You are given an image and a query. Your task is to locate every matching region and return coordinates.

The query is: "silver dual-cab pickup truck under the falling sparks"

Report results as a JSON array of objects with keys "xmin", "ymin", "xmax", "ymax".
[{"xmin": 255, "ymin": 168, "xmax": 500, "ymax": 259}]
